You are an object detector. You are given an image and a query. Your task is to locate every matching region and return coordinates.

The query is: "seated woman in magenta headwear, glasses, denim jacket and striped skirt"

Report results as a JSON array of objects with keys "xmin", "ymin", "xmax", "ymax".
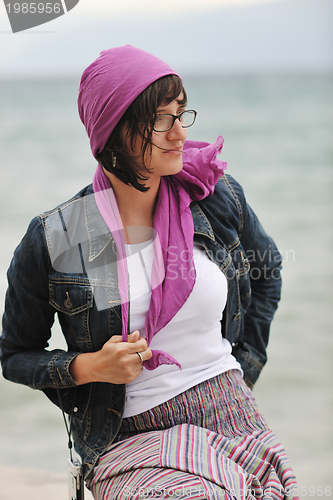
[{"xmin": 1, "ymin": 46, "xmax": 297, "ymax": 499}]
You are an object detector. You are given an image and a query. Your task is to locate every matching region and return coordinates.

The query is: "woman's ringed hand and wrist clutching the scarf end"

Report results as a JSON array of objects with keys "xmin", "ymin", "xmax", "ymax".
[{"xmin": 69, "ymin": 331, "xmax": 152, "ymax": 385}]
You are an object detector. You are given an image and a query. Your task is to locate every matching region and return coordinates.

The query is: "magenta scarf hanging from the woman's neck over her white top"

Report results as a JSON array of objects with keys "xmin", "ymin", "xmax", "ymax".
[{"xmin": 93, "ymin": 136, "xmax": 227, "ymax": 370}]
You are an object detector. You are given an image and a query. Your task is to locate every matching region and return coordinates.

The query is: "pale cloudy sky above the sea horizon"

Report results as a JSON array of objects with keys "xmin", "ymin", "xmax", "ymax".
[{"xmin": 0, "ymin": 0, "xmax": 333, "ymax": 79}]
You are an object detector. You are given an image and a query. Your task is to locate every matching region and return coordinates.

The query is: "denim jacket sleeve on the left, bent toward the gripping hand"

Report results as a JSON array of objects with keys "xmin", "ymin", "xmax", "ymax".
[{"xmin": 0, "ymin": 217, "xmax": 79, "ymax": 392}]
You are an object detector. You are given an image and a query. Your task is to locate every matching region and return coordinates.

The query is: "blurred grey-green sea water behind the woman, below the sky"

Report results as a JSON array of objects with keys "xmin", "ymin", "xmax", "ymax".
[{"xmin": 0, "ymin": 75, "xmax": 333, "ymax": 490}]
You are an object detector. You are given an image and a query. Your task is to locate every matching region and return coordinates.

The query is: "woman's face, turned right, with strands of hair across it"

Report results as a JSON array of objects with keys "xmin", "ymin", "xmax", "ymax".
[{"xmin": 126, "ymin": 93, "xmax": 187, "ymax": 185}]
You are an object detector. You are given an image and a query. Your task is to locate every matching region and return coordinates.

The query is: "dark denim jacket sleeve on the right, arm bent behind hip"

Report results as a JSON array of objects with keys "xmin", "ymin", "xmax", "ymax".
[{"xmin": 229, "ymin": 177, "xmax": 282, "ymax": 388}]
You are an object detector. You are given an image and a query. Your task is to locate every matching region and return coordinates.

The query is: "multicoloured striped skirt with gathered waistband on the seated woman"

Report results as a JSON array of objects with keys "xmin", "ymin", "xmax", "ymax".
[{"xmin": 87, "ymin": 370, "xmax": 298, "ymax": 500}]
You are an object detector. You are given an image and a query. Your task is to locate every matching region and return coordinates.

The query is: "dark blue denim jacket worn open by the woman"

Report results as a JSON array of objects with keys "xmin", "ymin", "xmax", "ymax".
[{"xmin": 0, "ymin": 175, "xmax": 281, "ymax": 477}]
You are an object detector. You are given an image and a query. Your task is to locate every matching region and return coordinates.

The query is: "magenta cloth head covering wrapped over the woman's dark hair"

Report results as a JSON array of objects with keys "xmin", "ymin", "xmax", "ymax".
[{"xmin": 78, "ymin": 45, "xmax": 178, "ymax": 158}]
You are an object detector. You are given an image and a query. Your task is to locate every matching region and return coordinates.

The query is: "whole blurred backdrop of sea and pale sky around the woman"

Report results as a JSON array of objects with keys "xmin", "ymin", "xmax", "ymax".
[{"xmin": 0, "ymin": 0, "xmax": 333, "ymax": 497}]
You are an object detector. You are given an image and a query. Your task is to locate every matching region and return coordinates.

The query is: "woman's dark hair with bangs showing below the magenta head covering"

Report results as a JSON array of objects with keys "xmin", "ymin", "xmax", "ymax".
[{"xmin": 97, "ymin": 75, "xmax": 187, "ymax": 191}]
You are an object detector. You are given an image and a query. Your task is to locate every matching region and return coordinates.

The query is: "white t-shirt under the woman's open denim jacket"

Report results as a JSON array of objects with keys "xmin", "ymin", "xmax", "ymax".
[{"xmin": 124, "ymin": 242, "xmax": 241, "ymax": 417}]
